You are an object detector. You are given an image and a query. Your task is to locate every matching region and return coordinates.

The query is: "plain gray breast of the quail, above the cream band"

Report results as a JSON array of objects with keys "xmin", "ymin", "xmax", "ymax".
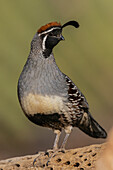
[{"xmin": 18, "ymin": 55, "xmax": 68, "ymax": 97}]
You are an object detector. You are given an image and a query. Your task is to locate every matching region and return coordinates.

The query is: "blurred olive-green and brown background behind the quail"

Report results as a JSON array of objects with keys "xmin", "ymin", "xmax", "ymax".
[{"xmin": 0, "ymin": 0, "xmax": 113, "ymax": 159}]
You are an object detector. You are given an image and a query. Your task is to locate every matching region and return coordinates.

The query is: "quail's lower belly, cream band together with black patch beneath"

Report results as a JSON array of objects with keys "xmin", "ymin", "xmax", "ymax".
[{"xmin": 21, "ymin": 93, "xmax": 68, "ymax": 130}]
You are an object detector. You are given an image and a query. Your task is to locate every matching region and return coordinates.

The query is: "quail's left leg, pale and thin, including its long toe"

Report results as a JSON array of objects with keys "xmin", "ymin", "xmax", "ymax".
[{"xmin": 46, "ymin": 130, "xmax": 61, "ymax": 166}]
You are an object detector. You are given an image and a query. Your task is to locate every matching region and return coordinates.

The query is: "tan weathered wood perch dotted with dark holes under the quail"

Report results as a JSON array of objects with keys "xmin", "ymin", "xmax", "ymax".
[{"xmin": 0, "ymin": 144, "xmax": 106, "ymax": 170}]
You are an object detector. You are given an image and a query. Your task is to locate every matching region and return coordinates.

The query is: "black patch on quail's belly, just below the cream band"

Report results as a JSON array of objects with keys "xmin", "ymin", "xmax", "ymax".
[{"xmin": 27, "ymin": 113, "xmax": 65, "ymax": 130}]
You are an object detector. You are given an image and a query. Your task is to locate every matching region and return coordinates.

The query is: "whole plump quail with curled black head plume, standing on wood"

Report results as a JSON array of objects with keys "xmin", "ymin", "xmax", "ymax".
[{"xmin": 18, "ymin": 21, "xmax": 107, "ymax": 150}]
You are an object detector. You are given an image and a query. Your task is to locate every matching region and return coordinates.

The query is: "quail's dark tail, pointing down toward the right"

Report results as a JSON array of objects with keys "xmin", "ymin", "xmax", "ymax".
[{"xmin": 78, "ymin": 113, "xmax": 107, "ymax": 138}]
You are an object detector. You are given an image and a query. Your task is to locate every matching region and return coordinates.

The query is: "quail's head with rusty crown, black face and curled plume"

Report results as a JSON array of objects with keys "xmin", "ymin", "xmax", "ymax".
[{"xmin": 30, "ymin": 21, "xmax": 79, "ymax": 58}]
